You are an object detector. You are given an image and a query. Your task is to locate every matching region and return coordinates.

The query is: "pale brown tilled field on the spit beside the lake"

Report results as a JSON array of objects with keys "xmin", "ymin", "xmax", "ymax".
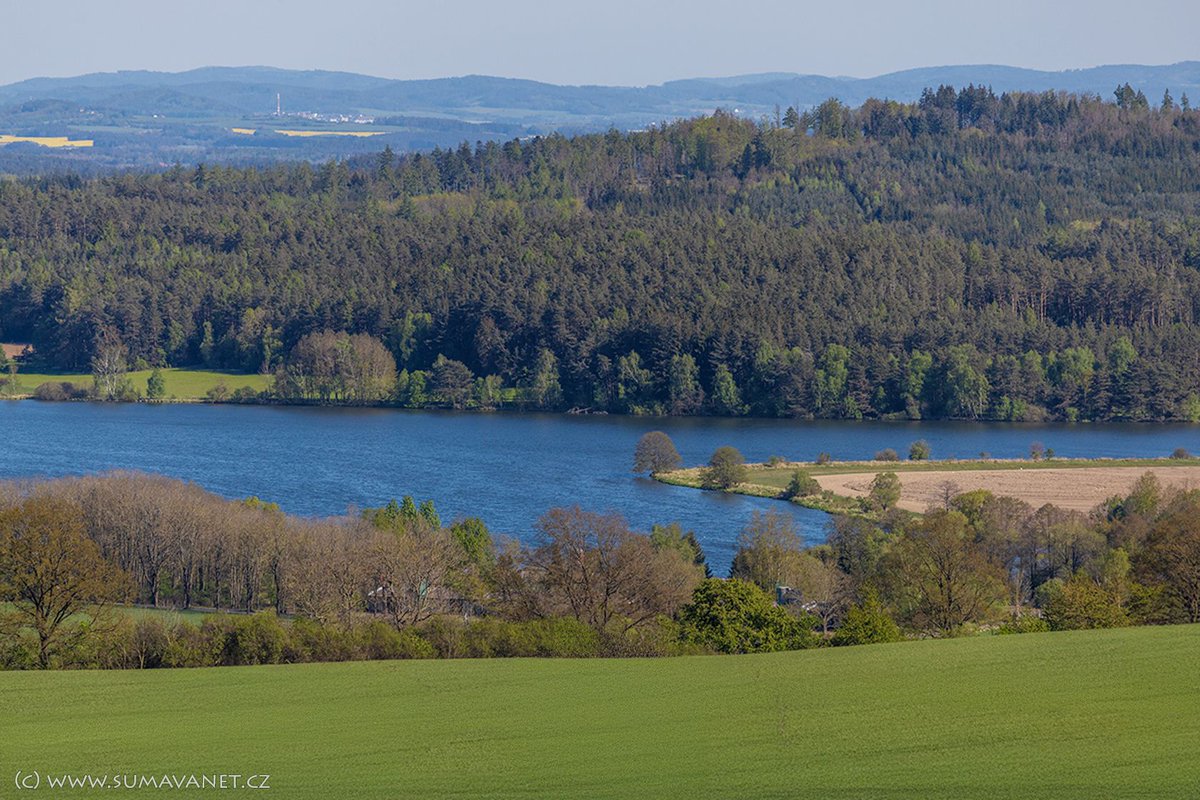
[{"xmin": 816, "ymin": 467, "xmax": 1200, "ymax": 511}]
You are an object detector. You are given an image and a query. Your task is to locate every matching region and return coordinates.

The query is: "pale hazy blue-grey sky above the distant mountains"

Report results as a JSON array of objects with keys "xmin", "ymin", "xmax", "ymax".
[{"xmin": 0, "ymin": 0, "xmax": 1200, "ymax": 85}]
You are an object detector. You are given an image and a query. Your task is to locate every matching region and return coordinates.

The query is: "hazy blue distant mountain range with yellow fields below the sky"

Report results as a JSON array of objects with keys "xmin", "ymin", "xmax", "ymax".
[{"xmin": 0, "ymin": 61, "xmax": 1200, "ymax": 172}]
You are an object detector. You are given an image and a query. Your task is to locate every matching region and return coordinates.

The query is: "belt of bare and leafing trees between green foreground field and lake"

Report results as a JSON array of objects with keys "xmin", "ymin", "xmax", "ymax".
[{"xmin": 0, "ymin": 474, "xmax": 1200, "ymax": 668}]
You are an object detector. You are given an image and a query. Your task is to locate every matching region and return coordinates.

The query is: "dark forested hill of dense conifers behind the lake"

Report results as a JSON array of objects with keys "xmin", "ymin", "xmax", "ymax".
[{"xmin": 0, "ymin": 88, "xmax": 1200, "ymax": 420}]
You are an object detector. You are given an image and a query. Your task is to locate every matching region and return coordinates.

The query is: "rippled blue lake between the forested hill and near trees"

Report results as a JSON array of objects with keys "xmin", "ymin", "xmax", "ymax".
[{"xmin": 0, "ymin": 401, "xmax": 1200, "ymax": 575}]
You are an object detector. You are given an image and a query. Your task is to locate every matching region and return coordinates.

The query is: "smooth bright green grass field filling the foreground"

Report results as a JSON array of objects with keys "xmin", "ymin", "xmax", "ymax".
[{"xmin": 0, "ymin": 626, "xmax": 1200, "ymax": 800}]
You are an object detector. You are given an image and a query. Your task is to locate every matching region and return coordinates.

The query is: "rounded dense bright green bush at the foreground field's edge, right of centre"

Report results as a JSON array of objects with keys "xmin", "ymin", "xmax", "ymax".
[{"xmin": 679, "ymin": 578, "xmax": 818, "ymax": 652}]
